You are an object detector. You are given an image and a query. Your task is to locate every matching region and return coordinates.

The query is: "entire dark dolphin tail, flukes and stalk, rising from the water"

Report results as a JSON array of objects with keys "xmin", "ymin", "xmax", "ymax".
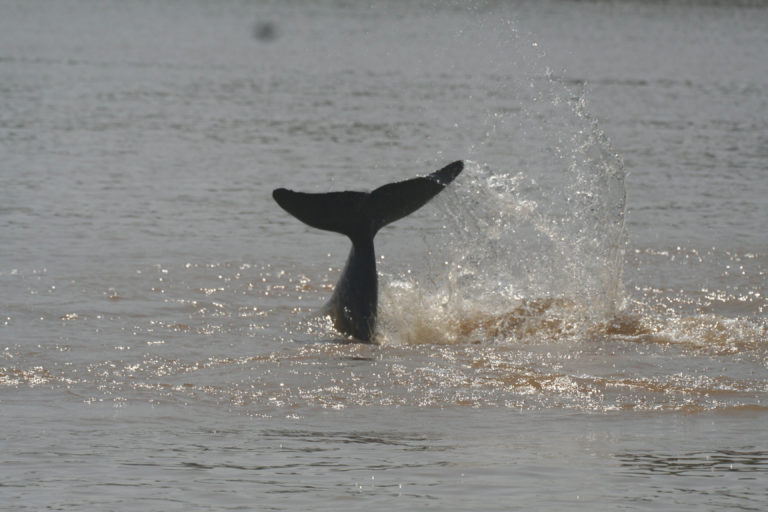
[{"xmin": 272, "ymin": 161, "xmax": 464, "ymax": 341}]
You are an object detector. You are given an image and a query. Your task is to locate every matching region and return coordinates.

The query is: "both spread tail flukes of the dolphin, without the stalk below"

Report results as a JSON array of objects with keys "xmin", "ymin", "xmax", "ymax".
[{"xmin": 272, "ymin": 161, "xmax": 464, "ymax": 242}]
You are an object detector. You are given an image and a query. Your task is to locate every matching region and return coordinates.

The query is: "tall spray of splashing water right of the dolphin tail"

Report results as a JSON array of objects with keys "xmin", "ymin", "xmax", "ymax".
[{"xmin": 381, "ymin": 84, "xmax": 626, "ymax": 344}]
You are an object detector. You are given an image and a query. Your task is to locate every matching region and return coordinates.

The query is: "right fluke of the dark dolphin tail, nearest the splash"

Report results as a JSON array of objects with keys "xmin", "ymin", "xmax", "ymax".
[{"xmin": 369, "ymin": 161, "xmax": 464, "ymax": 233}]
